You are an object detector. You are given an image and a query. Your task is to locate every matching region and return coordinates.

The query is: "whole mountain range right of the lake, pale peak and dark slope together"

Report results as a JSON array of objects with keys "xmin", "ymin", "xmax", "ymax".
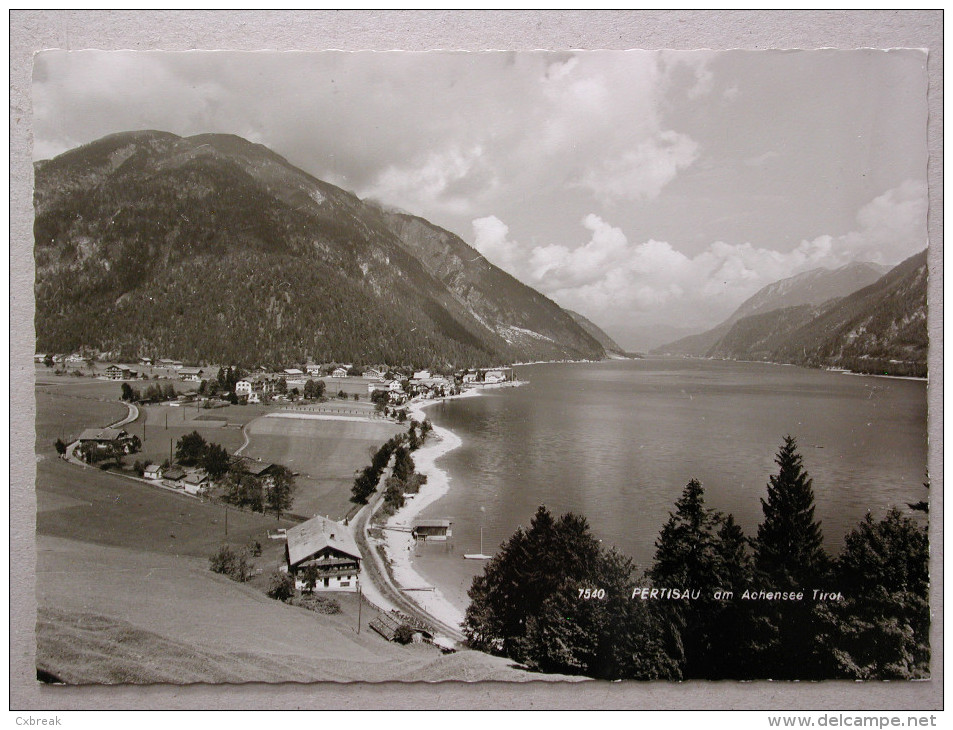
[{"xmin": 659, "ymin": 250, "xmax": 929, "ymax": 376}]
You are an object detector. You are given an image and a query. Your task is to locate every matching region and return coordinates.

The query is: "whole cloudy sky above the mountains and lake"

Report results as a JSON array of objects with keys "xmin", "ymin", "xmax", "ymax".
[{"xmin": 33, "ymin": 50, "xmax": 927, "ymax": 348}]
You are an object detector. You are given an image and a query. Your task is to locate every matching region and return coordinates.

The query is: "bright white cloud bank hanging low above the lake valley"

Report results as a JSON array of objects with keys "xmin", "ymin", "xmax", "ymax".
[{"xmin": 473, "ymin": 181, "xmax": 926, "ymax": 333}]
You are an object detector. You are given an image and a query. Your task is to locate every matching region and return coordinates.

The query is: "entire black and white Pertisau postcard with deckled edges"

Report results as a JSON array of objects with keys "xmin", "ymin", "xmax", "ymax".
[{"xmin": 14, "ymin": 9, "xmax": 938, "ymax": 704}]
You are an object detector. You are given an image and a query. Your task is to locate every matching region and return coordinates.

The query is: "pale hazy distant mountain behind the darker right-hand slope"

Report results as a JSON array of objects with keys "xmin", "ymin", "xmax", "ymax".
[{"xmin": 655, "ymin": 262, "xmax": 890, "ymax": 357}]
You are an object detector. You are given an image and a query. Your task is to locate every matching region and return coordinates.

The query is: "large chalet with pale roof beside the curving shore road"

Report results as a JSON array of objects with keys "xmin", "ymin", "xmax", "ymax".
[{"xmin": 285, "ymin": 517, "xmax": 361, "ymax": 591}]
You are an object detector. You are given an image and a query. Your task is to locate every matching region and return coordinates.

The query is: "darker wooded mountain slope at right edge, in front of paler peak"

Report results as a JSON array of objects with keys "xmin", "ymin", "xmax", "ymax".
[{"xmin": 706, "ymin": 251, "xmax": 929, "ymax": 377}]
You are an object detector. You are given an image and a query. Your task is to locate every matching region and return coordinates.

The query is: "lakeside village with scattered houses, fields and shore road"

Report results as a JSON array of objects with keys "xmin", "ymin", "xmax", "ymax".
[{"xmin": 35, "ymin": 354, "xmax": 514, "ymax": 651}]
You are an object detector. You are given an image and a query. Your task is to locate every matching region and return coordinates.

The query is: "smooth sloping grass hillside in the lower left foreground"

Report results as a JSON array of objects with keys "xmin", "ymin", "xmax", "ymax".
[{"xmin": 37, "ymin": 535, "xmax": 553, "ymax": 684}]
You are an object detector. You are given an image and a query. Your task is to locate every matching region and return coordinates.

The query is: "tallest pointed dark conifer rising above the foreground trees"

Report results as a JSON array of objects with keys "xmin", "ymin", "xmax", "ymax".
[{"xmin": 755, "ymin": 436, "xmax": 829, "ymax": 590}]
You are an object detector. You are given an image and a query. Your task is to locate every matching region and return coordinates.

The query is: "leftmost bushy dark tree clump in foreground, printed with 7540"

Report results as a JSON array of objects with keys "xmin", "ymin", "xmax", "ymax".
[{"xmin": 464, "ymin": 507, "xmax": 677, "ymax": 679}]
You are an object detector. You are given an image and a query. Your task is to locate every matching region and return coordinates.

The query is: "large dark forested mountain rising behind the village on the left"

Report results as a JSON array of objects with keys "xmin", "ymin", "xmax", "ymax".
[{"xmin": 34, "ymin": 131, "xmax": 605, "ymax": 368}]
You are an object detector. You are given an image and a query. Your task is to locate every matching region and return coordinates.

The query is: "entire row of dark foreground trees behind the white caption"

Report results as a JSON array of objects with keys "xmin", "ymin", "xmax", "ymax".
[{"xmin": 464, "ymin": 437, "xmax": 930, "ymax": 680}]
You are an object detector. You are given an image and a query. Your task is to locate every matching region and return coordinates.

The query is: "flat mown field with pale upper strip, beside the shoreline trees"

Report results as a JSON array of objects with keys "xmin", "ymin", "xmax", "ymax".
[{"xmin": 243, "ymin": 418, "xmax": 405, "ymax": 519}]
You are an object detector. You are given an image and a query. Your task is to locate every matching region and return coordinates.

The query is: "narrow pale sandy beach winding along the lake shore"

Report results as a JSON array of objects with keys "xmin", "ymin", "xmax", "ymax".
[{"xmin": 384, "ymin": 389, "xmax": 480, "ymax": 626}]
